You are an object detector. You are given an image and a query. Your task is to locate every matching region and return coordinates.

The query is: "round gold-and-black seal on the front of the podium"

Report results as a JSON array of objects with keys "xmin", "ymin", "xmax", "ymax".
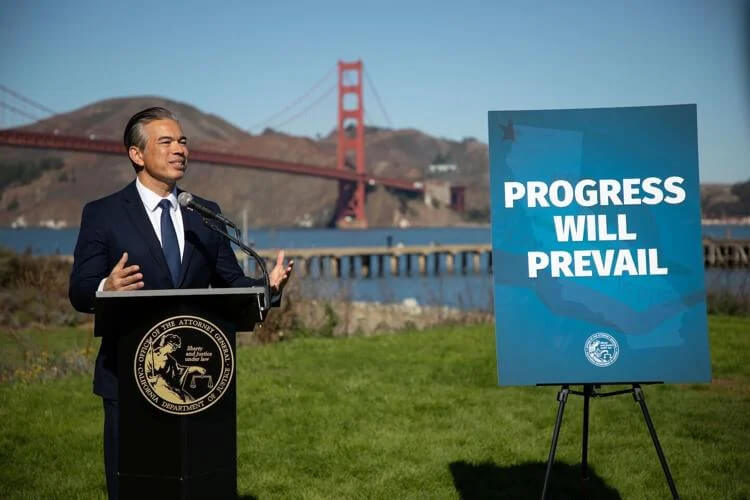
[{"xmin": 133, "ymin": 316, "xmax": 234, "ymax": 415}]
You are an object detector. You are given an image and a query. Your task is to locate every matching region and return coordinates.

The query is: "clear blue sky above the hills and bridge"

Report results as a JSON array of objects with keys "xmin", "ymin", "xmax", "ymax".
[{"xmin": 0, "ymin": 0, "xmax": 750, "ymax": 182}]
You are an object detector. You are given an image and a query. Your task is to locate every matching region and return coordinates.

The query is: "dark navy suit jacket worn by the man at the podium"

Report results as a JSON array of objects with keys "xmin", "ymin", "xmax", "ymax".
[{"xmin": 68, "ymin": 181, "xmax": 264, "ymax": 399}]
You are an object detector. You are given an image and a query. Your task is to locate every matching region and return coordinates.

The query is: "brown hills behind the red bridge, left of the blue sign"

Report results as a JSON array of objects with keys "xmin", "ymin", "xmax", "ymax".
[{"xmin": 0, "ymin": 97, "xmax": 488, "ymax": 227}]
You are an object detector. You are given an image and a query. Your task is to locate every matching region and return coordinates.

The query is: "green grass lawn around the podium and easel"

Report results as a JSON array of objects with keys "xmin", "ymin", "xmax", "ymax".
[{"xmin": 0, "ymin": 317, "xmax": 750, "ymax": 499}]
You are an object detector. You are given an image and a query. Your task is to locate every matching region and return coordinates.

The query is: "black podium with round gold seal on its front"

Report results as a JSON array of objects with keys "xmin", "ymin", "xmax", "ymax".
[{"xmin": 95, "ymin": 287, "xmax": 264, "ymax": 500}]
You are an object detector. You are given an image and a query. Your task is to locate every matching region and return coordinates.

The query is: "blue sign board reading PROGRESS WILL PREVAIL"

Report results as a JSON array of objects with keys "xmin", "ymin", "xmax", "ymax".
[{"xmin": 489, "ymin": 105, "xmax": 711, "ymax": 385}]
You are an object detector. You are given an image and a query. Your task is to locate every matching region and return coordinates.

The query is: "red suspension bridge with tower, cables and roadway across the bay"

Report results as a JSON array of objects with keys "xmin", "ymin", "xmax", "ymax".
[{"xmin": 0, "ymin": 61, "xmax": 464, "ymax": 228}]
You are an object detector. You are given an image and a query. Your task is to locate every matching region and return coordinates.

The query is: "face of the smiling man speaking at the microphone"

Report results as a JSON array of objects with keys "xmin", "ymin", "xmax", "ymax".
[{"xmin": 130, "ymin": 119, "xmax": 188, "ymax": 185}]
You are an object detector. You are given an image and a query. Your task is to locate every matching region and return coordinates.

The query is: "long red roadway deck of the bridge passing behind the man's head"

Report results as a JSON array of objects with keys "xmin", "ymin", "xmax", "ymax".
[{"xmin": 0, "ymin": 129, "xmax": 424, "ymax": 193}]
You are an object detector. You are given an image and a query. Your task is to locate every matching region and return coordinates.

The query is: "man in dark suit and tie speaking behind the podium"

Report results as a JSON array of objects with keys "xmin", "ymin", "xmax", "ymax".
[{"xmin": 69, "ymin": 108, "xmax": 293, "ymax": 498}]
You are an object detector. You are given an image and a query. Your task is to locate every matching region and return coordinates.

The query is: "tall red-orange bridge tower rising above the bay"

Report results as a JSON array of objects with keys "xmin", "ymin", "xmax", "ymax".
[{"xmin": 335, "ymin": 60, "xmax": 367, "ymax": 228}]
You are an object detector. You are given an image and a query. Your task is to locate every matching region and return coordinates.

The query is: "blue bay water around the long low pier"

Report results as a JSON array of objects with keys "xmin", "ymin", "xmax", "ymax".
[{"xmin": 0, "ymin": 225, "xmax": 750, "ymax": 311}]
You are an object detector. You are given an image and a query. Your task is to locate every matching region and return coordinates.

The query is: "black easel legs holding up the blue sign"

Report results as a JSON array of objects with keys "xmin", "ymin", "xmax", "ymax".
[{"xmin": 542, "ymin": 384, "xmax": 680, "ymax": 500}]
